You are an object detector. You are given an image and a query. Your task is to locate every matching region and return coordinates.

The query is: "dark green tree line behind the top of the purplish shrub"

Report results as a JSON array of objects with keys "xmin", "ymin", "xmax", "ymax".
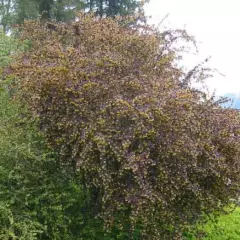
[{"xmin": 0, "ymin": 0, "xmax": 147, "ymax": 33}]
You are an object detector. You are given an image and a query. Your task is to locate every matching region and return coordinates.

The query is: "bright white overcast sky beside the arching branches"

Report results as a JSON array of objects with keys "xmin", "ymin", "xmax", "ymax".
[{"xmin": 145, "ymin": 0, "xmax": 240, "ymax": 97}]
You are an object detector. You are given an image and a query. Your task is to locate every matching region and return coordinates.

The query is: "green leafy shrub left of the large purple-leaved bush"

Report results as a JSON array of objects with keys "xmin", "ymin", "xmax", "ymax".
[{"xmin": 0, "ymin": 83, "xmax": 93, "ymax": 240}]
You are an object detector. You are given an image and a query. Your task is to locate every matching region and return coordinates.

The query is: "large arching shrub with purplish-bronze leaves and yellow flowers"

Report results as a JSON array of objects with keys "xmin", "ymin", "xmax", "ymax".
[{"xmin": 7, "ymin": 15, "xmax": 240, "ymax": 240}]
